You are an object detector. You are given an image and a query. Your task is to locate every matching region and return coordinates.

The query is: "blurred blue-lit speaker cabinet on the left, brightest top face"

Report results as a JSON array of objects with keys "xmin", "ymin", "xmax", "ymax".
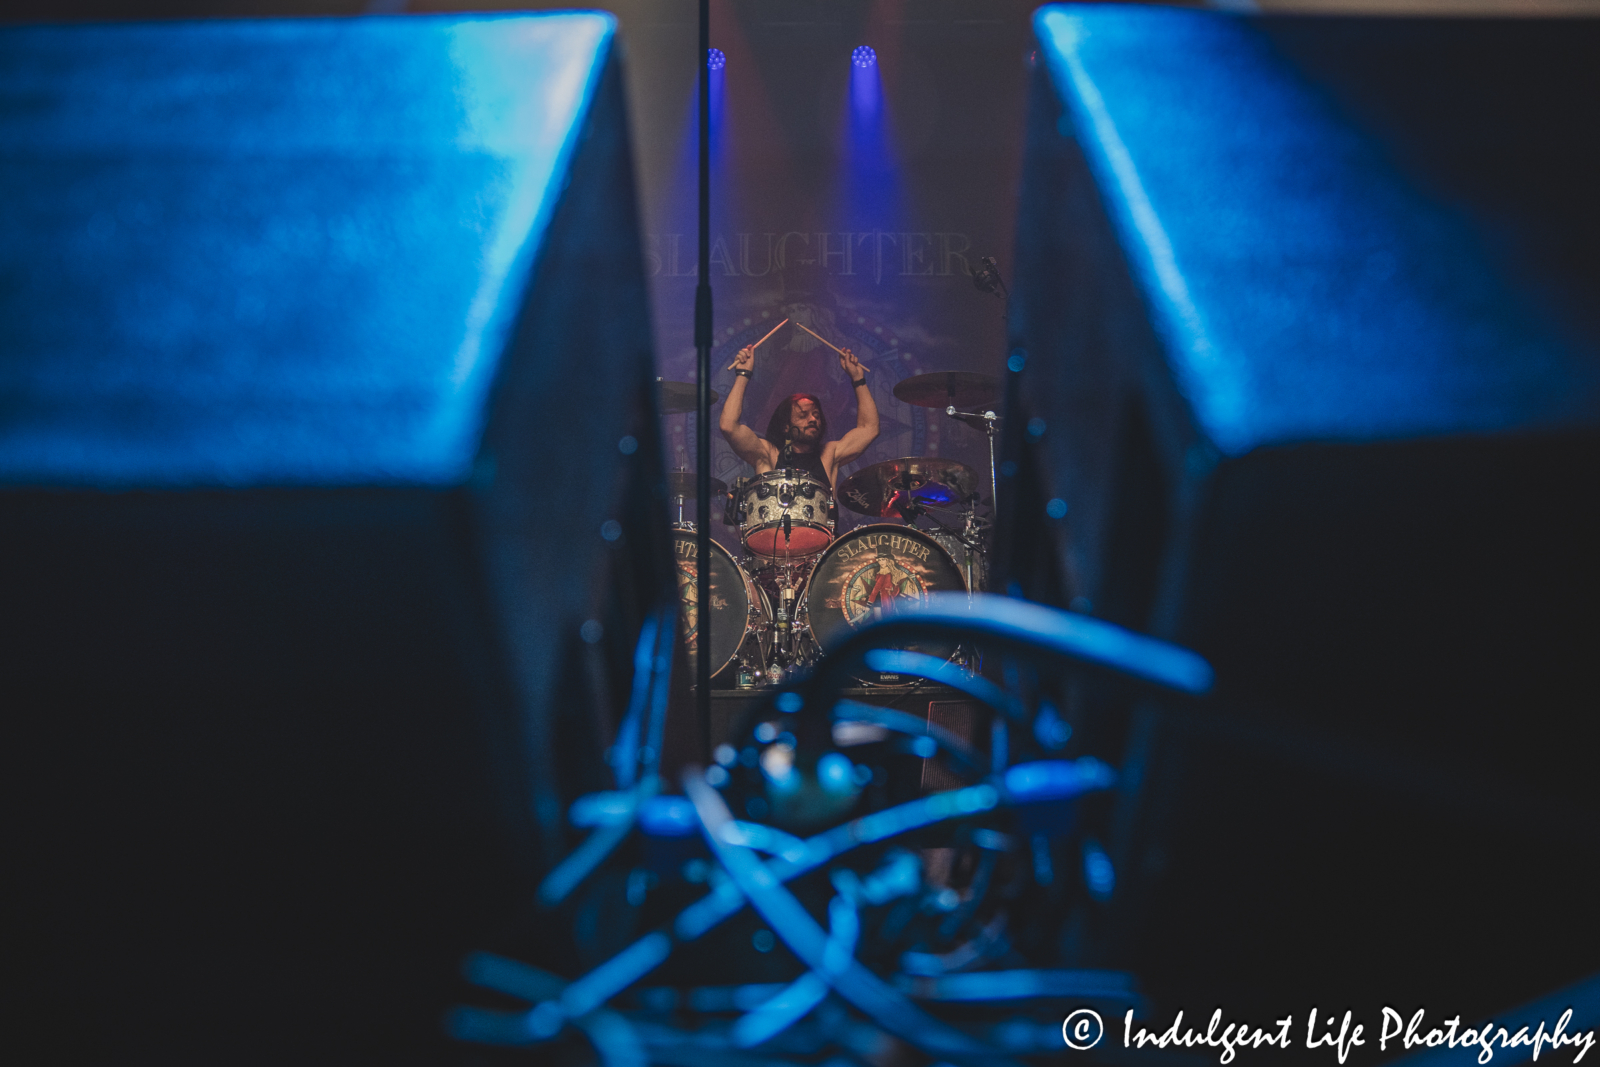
[{"xmin": 0, "ymin": 14, "xmax": 672, "ymax": 1064}]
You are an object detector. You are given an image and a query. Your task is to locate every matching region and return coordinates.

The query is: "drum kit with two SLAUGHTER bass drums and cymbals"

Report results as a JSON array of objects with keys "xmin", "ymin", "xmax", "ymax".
[{"xmin": 661, "ymin": 371, "xmax": 1000, "ymax": 688}]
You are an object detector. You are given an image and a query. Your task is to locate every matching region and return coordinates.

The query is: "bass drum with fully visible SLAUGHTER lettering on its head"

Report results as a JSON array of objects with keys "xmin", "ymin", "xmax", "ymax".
[{"xmin": 805, "ymin": 523, "xmax": 966, "ymax": 685}]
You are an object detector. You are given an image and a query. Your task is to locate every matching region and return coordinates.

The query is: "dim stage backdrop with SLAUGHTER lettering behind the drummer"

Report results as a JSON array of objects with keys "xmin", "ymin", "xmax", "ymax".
[{"xmin": 410, "ymin": 0, "xmax": 1034, "ymax": 531}]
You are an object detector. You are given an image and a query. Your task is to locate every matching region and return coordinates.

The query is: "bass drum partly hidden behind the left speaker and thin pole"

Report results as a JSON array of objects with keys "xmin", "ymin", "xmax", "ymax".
[{"xmin": 672, "ymin": 523, "xmax": 773, "ymax": 678}]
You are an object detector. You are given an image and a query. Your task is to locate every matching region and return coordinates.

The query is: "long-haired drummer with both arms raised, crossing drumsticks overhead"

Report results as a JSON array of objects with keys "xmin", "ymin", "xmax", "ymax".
[{"xmin": 718, "ymin": 347, "xmax": 878, "ymax": 494}]
